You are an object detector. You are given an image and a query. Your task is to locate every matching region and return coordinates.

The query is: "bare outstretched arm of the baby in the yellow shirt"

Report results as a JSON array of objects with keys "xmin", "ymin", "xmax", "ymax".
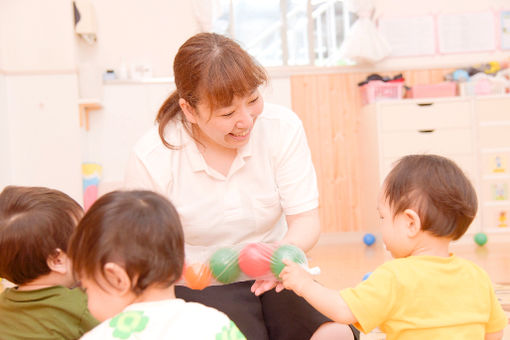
[{"xmin": 280, "ymin": 260, "xmax": 358, "ymax": 324}]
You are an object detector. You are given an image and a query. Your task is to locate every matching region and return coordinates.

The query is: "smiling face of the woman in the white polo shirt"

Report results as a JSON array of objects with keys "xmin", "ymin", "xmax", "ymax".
[{"xmin": 192, "ymin": 90, "xmax": 264, "ymax": 149}]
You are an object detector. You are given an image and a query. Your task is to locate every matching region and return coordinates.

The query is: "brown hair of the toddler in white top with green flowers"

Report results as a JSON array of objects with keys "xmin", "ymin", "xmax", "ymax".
[{"xmin": 69, "ymin": 190, "xmax": 184, "ymax": 295}]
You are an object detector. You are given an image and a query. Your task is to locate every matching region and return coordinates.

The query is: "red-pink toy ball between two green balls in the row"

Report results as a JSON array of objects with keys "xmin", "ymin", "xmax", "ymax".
[{"xmin": 239, "ymin": 243, "xmax": 273, "ymax": 278}]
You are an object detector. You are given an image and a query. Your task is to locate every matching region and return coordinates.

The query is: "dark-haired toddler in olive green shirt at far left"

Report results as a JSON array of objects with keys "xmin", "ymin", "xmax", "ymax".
[{"xmin": 0, "ymin": 186, "xmax": 98, "ymax": 340}]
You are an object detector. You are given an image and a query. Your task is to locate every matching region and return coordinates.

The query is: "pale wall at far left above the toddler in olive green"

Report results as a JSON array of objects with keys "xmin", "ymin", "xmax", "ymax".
[{"xmin": 0, "ymin": 0, "xmax": 82, "ymax": 202}]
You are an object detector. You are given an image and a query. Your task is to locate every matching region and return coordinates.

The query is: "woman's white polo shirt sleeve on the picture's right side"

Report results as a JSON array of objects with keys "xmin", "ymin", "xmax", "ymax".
[{"xmin": 276, "ymin": 112, "xmax": 319, "ymax": 215}]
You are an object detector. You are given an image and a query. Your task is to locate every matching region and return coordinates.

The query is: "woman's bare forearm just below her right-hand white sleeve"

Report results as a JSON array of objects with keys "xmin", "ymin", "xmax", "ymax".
[{"xmin": 281, "ymin": 208, "xmax": 321, "ymax": 252}]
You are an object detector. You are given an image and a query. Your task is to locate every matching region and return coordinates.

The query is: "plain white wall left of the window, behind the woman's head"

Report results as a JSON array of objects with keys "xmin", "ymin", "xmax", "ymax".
[{"xmin": 77, "ymin": 0, "xmax": 199, "ymax": 77}]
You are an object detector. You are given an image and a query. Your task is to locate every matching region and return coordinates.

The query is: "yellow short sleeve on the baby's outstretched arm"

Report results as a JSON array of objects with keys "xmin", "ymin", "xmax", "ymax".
[{"xmin": 340, "ymin": 267, "xmax": 398, "ymax": 333}]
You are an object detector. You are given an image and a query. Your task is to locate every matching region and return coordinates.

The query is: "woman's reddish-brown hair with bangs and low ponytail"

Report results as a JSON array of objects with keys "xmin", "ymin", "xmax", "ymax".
[{"xmin": 156, "ymin": 33, "xmax": 267, "ymax": 149}]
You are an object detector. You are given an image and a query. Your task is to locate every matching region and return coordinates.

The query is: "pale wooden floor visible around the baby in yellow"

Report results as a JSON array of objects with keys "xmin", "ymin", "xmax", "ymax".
[{"xmin": 309, "ymin": 233, "xmax": 510, "ymax": 340}]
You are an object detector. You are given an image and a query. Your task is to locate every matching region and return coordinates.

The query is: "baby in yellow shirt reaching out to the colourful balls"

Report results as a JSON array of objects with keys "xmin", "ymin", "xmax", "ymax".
[{"xmin": 280, "ymin": 155, "xmax": 508, "ymax": 340}]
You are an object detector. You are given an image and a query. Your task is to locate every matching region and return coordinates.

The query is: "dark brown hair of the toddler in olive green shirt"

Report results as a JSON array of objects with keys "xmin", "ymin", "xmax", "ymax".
[{"xmin": 0, "ymin": 186, "xmax": 83, "ymax": 285}]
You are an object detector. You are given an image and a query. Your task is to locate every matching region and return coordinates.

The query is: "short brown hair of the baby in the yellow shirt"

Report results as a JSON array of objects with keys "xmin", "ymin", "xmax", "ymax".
[{"xmin": 384, "ymin": 155, "xmax": 478, "ymax": 240}]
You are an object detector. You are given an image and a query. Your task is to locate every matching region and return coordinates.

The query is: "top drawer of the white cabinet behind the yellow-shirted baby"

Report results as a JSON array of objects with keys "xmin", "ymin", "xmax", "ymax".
[{"xmin": 380, "ymin": 101, "xmax": 472, "ymax": 131}]
